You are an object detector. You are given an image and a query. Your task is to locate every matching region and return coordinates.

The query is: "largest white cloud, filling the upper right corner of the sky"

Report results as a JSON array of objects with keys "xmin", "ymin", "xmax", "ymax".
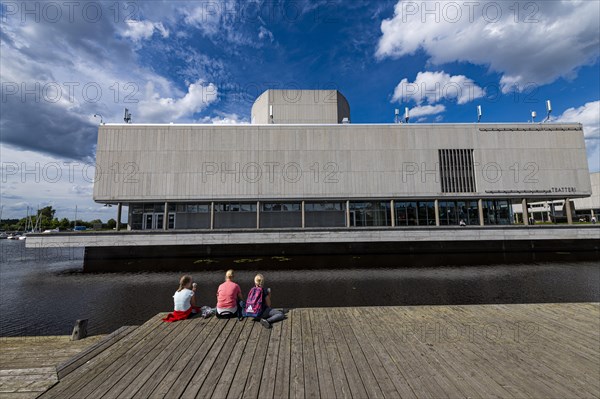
[{"xmin": 375, "ymin": 0, "xmax": 600, "ymax": 93}]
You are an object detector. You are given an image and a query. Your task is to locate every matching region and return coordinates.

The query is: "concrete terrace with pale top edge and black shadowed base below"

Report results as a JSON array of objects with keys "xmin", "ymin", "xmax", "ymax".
[{"xmin": 26, "ymin": 225, "xmax": 600, "ymax": 272}]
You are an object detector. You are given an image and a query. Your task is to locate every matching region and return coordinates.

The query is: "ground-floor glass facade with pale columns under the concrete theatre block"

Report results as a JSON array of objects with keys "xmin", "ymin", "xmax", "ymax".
[{"xmin": 129, "ymin": 198, "xmax": 520, "ymax": 230}]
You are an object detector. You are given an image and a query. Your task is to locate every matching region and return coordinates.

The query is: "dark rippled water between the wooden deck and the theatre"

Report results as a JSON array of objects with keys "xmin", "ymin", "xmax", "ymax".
[{"xmin": 0, "ymin": 240, "xmax": 600, "ymax": 336}]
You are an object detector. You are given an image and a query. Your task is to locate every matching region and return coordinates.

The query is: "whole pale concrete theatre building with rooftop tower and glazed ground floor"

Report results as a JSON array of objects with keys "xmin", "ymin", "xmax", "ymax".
[{"xmin": 94, "ymin": 90, "xmax": 592, "ymax": 230}]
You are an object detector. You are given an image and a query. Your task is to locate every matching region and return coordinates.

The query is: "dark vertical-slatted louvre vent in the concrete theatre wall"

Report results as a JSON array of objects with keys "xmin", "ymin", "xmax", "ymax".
[{"xmin": 438, "ymin": 149, "xmax": 476, "ymax": 193}]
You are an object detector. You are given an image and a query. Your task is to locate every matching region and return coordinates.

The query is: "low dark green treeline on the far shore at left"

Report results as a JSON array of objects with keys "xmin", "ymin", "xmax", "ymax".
[{"xmin": 0, "ymin": 206, "xmax": 117, "ymax": 231}]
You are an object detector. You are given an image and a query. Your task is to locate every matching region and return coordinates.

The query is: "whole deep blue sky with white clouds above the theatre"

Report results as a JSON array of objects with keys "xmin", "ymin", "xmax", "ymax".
[{"xmin": 0, "ymin": 0, "xmax": 600, "ymax": 220}]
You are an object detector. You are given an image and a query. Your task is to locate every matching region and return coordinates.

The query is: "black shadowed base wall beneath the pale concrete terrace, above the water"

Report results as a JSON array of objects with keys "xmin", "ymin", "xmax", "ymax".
[{"xmin": 78, "ymin": 240, "xmax": 600, "ymax": 272}]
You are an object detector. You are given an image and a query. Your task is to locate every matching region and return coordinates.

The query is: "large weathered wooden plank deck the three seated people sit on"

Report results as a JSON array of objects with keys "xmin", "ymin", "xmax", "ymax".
[{"xmin": 40, "ymin": 303, "xmax": 600, "ymax": 399}]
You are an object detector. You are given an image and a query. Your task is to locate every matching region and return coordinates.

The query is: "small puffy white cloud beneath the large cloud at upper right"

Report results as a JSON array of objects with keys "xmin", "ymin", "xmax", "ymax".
[{"xmin": 392, "ymin": 71, "xmax": 485, "ymax": 104}]
